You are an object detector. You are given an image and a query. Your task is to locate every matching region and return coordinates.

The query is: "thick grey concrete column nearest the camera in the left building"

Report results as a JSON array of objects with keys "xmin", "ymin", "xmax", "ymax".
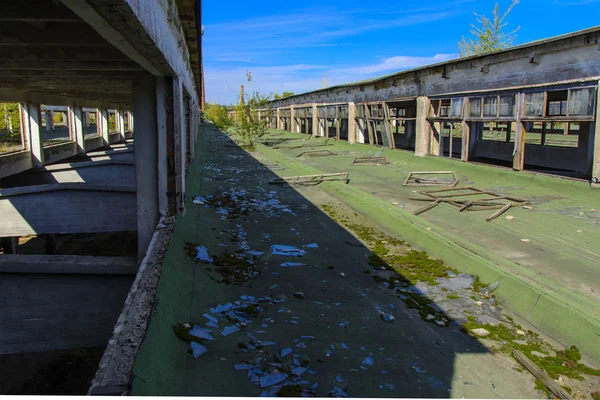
[{"xmin": 132, "ymin": 74, "xmax": 159, "ymax": 259}]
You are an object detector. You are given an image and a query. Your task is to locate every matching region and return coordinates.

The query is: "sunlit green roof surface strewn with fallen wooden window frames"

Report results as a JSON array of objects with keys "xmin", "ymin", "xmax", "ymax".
[{"xmin": 254, "ymin": 131, "xmax": 600, "ymax": 365}]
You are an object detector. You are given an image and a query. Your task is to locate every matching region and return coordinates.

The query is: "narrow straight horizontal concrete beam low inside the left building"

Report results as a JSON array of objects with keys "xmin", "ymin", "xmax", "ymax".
[{"xmin": 0, "ymin": 254, "xmax": 137, "ymax": 275}]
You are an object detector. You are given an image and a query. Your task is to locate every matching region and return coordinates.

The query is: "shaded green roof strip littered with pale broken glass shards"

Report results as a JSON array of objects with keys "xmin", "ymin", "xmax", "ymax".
[{"xmin": 132, "ymin": 127, "xmax": 539, "ymax": 398}]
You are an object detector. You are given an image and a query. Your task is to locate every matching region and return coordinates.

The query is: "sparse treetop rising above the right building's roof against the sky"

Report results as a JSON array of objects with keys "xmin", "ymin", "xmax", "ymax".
[{"xmin": 458, "ymin": 0, "xmax": 521, "ymax": 57}]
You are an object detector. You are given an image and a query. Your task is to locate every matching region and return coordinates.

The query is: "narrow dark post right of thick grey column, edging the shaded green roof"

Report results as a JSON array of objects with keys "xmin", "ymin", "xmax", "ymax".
[{"xmin": 173, "ymin": 78, "xmax": 187, "ymax": 214}]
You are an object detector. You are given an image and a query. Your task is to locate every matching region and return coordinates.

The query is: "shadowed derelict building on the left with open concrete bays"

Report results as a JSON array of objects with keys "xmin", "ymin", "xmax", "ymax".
[{"xmin": 0, "ymin": 0, "xmax": 202, "ymax": 394}]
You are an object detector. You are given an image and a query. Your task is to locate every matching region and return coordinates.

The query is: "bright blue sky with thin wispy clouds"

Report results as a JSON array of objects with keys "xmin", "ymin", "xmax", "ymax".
[{"xmin": 202, "ymin": 0, "xmax": 600, "ymax": 104}]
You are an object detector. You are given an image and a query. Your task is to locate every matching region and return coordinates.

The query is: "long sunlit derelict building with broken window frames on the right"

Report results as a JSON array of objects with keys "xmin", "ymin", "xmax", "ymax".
[{"xmin": 241, "ymin": 28, "xmax": 600, "ymax": 184}]
